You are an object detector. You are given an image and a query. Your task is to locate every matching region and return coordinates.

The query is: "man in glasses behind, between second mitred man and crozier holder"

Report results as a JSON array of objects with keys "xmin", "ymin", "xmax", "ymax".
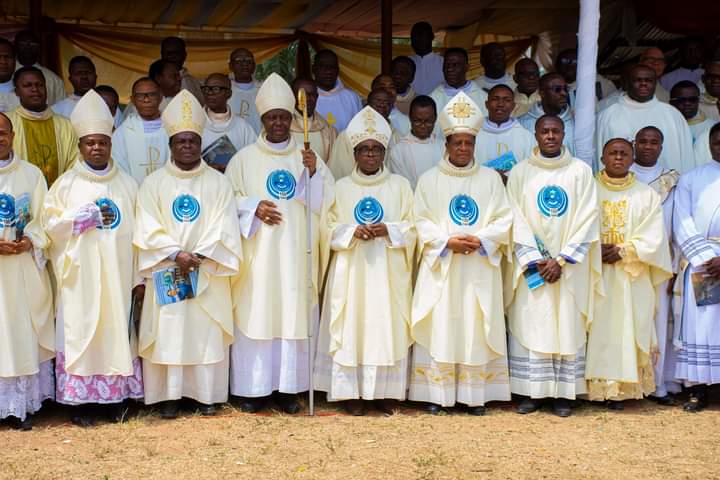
[{"xmin": 202, "ymin": 73, "xmax": 257, "ymax": 172}]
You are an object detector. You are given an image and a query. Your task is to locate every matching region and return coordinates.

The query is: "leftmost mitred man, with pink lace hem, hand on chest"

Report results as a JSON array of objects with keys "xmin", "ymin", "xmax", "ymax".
[{"xmin": 43, "ymin": 90, "xmax": 143, "ymax": 426}]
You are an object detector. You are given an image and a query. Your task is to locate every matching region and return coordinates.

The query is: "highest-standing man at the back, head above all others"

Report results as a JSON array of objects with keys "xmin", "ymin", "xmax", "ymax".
[{"xmin": 410, "ymin": 22, "xmax": 443, "ymax": 95}]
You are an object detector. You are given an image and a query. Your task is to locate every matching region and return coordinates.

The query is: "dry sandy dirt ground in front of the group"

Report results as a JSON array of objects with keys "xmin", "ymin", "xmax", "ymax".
[{"xmin": 0, "ymin": 395, "xmax": 720, "ymax": 480}]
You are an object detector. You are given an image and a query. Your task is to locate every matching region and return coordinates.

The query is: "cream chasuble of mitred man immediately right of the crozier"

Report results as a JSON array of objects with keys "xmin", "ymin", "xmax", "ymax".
[{"xmin": 319, "ymin": 169, "xmax": 416, "ymax": 367}]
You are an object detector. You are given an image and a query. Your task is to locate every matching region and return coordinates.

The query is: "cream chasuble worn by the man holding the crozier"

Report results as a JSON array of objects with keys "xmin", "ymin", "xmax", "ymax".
[{"xmin": 226, "ymin": 135, "xmax": 335, "ymax": 340}]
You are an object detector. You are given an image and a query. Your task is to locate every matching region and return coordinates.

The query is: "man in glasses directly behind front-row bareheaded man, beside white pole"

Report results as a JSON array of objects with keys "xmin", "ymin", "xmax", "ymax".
[{"xmin": 518, "ymin": 73, "xmax": 575, "ymax": 153}]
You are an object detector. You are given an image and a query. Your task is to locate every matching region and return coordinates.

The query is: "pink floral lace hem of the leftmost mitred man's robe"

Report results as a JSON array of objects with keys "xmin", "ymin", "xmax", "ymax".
[{"xmin": 55, "ymin": 352, "xmax": 143, "ymax": 405}]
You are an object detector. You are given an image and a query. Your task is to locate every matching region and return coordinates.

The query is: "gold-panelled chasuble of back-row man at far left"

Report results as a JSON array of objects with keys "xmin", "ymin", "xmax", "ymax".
[{"xmin": 7, "ymin": 106, "xmax": 78, "ymax": 185}]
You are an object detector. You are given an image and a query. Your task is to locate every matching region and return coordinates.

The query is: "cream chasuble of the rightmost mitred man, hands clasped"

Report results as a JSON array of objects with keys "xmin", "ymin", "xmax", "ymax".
[{"xmin": 412, "ymin": 155, "xmax": 512, "ymax": 365}]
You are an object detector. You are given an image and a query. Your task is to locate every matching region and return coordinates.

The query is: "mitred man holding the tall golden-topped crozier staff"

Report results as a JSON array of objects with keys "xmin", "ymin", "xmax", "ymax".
[{"xmin": 226, "ymin": 73, "xmax": 334, "ymax": 413}]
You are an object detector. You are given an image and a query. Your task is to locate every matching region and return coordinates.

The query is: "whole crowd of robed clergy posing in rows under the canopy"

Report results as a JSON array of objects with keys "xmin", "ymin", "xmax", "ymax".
[{"xmin": 0, "ymin": 22, "xmax": 720, "ymax": 429}]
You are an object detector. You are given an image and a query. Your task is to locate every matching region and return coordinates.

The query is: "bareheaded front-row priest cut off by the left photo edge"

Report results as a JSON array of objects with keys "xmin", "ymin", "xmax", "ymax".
[{"xmin": 0, "ymin": 110, "xmax": 55, "ymax": 430}]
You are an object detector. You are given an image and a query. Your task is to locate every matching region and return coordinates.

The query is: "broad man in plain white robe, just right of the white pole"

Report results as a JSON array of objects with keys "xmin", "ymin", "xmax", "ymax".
[{"xmin": 595, "ymin": 65, "xmax": 695, "ymax": 174}]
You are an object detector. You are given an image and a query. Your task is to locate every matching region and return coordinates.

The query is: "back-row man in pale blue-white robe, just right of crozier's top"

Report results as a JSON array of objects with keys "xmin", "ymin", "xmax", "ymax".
[{"xmin": 312, "ymin": 50, "xmax": 362, "ymax": 133}]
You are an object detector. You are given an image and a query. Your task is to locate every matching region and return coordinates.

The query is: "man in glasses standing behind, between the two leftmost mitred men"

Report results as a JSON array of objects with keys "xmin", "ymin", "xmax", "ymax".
[{"xmin": 112, "ymin": 77, "xmax": 170, "ymax": 184}]
